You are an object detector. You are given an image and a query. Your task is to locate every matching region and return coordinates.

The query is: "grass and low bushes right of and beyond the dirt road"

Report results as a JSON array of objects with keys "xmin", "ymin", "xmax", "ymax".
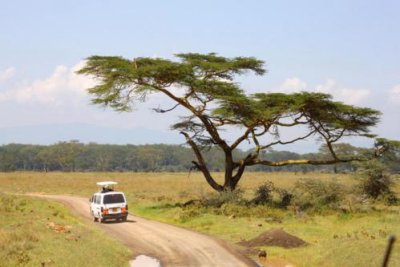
[{"xmin": 0, "ymin": 172, "xmax": 400, "ymax": 266}]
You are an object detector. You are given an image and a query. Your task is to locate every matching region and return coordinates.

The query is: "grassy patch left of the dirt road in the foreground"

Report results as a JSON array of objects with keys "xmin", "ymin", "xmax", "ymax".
[{"xmin": 0, "ymin": 193, "xmax": 131, "ymax": 267}]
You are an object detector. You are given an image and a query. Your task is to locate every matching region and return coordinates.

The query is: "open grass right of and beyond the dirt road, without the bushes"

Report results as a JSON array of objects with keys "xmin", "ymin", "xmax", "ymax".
[{"xmin": 0, "ymin": 172, "xmax": 400, "ymax": 266}]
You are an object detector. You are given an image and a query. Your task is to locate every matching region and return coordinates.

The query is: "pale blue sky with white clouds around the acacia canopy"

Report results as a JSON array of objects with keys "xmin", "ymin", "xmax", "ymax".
[{"xmin": 0, "ymin": 0, "xmax": 400, "ymax": 151}]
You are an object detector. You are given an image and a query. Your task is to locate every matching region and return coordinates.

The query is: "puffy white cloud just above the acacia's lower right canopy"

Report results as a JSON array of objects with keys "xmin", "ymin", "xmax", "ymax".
[{"xmin": 276, "ymin": 77, "xmax": 371, "ymax": 104}]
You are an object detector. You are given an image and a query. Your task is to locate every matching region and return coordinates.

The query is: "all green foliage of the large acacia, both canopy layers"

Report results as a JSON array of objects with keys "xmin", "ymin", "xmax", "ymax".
[{"xmin": 78, "ymin": 53, "xmax": 380, "ymax": 151}]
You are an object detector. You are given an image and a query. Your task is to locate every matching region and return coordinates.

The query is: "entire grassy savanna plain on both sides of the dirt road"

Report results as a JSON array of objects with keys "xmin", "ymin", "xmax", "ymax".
[{"xmin": 0, "ymin": 172, "xmax": 400, "ymax": 266}]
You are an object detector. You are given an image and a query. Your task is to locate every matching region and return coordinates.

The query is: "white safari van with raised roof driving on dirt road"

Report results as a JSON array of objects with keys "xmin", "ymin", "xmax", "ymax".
[{"xmin": 89, "ymin": 181, "xmax": 128, "ymax": 223}]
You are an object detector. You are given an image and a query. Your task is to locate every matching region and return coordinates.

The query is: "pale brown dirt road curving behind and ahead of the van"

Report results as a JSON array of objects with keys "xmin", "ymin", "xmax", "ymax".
[{"xmin": 32, "ymin": 195, "xmax": 257, "ymax": 267}]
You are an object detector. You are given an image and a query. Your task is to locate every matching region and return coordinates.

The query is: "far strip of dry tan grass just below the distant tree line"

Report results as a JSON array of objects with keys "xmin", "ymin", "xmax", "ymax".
[{"xmin": 0, "ymin": 172, "xmax": 354, "ymax": 201}]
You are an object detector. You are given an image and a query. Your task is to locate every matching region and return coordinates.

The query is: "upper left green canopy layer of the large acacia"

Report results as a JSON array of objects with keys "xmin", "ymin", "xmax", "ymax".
[{"xmin": 78, "ymin": 53, "xmax": 265, "ymax": 111}]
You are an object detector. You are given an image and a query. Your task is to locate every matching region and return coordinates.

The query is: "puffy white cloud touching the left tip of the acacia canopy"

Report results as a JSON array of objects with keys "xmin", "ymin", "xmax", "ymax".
[{"xmin": 0, "ymin": 62, "xmax": 94, "ymax": 106}]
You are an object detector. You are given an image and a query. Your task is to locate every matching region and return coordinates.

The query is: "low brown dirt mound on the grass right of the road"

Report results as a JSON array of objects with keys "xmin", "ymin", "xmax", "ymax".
[{"xmin": 238, "ymin": 229, "xmax": 307, "ymax": 248}]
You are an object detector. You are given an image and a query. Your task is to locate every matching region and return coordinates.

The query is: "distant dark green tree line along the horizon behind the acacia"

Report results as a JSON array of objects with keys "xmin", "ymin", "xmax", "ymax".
[{"xmin": 0, "ymin": 141, "xmax": 400, "ymax": 172}]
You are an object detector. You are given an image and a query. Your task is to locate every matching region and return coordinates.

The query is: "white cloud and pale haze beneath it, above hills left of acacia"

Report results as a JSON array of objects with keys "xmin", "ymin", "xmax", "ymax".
[{"xmin": 0, "ymin": 62, "xmax": 178, "ymax": 130}]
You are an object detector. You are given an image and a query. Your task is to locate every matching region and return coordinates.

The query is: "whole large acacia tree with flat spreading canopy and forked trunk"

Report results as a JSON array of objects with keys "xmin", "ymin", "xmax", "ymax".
[{"xmin": 78, "ymin": 53, "xmax": 386, "ymax": 191}]
